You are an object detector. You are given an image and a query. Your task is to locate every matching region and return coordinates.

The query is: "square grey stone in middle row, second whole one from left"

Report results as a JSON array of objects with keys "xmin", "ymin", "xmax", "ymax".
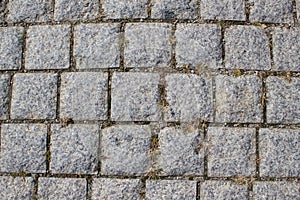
[{"xmin": 60, "ymin": 72, "xmax": 108, "ymax": 120}]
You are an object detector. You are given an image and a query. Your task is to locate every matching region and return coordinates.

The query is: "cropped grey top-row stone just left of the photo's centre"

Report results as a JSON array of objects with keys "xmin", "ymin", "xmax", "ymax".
[{"xmin": 102, "ymin": 0, "xmax": 148, "ymax": 19}]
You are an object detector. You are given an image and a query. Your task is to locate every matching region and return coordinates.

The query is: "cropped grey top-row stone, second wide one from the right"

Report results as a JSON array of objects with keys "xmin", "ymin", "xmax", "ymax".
[{"xmin": 201, "ymin": 0, "xmax": 246, "ymax": 21}]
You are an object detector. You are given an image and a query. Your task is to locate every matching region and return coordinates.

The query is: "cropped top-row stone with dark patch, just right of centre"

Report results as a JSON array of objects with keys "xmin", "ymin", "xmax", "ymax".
[{"xmin": 151, "ymin": 0, "xmax": 198, "ymax": 19}]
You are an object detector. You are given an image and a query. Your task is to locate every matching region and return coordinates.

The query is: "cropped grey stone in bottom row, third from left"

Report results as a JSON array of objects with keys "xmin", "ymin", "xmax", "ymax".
[{"xmin": 92, "ymin": 178, "xmax": 140, "ymax": 200}]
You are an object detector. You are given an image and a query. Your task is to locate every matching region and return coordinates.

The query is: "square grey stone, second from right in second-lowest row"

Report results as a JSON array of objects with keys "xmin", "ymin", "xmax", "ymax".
[{"xmin": 207, "ymin": 127, "xmax": 256, "ymax": 177}]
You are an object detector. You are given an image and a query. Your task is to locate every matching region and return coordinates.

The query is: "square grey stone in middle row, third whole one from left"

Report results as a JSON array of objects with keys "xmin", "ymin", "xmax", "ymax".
[{"xmin": 111, "ymin": 72, "xmax": 160, "ymax": 121}]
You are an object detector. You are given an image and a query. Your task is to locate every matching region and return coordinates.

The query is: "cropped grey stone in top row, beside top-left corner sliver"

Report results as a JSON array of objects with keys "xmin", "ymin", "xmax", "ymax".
[{"xmin": 7, "ymin": 0, "xmax": 53, "ymax": 22}]
